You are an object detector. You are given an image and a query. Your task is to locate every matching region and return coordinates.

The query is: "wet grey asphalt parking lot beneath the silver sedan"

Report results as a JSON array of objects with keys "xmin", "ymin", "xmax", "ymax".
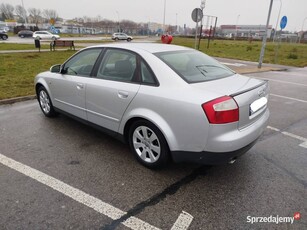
[{"xmin": 0, "ymin": 68, "xmax": 307, "ymax": 229}]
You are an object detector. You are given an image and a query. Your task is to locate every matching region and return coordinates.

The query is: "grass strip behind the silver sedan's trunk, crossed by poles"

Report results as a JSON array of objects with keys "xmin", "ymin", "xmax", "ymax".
[{"xmin": 172, "ymin": 37, "xmax": 307, "ymax": 67}]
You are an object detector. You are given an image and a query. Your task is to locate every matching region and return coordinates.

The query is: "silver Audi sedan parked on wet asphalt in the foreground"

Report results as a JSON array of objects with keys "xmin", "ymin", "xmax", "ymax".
[{"xmin": 35, "ymin": 43, "xmax": 269, "ymax": 168}]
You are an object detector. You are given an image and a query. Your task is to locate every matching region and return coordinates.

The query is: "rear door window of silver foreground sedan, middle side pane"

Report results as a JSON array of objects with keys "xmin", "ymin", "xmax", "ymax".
[{"xmin": 97, "ymin": 49, "xmax": 136, "ymax": 82}]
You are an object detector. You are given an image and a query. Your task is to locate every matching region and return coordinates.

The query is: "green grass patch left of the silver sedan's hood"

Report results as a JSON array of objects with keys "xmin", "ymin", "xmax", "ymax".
[{"xmin": 0, "ymin": 51, "xmax": 75, "ymax": 100}]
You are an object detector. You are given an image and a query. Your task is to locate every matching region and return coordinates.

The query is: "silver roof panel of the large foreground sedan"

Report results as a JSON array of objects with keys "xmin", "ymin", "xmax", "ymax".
[{"xmin": 88, "ymin": 43, "xmax": 193, "ymax": 53}]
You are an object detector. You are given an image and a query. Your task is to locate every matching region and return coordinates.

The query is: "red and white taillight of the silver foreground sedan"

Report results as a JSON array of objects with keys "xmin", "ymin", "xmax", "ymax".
[{"xmin": 202, "ymin": 96, "xmax": 239, "ymax": 124}]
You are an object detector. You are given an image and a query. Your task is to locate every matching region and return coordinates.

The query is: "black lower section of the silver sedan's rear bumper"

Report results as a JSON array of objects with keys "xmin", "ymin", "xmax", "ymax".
[{"xmin": 171, "ymin": 140, "xmax": 257, "ymax": 165}]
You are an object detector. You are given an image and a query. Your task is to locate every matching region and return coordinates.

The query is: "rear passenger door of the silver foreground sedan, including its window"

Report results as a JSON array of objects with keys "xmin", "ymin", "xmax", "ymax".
[{"xmin": 86, "ymin": 48, "xmax": 140, "ymax": 132}]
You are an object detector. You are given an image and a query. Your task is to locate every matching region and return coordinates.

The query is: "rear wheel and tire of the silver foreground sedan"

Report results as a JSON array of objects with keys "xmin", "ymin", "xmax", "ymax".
[{"xmin": 128, "ymin": 120, "xmax": 169, "ymax": 169}]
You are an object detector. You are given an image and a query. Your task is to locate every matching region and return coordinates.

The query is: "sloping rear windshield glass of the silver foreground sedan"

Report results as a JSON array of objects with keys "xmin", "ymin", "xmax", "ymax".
[{"xmin": 155, "ymin": 50, "xmax": 235, "ymax": 83}]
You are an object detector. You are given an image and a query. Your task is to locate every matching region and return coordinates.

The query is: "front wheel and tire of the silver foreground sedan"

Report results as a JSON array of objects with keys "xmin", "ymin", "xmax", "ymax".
[{"xmin": 37, "ymin": 86, "xmax": 57, "ymax": 117}]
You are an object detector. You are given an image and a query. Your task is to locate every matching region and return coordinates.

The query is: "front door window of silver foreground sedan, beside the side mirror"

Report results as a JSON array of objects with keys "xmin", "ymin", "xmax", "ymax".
[{"xmin": 62, "ymin": 49, "xmax": 101, "ymax": 77}]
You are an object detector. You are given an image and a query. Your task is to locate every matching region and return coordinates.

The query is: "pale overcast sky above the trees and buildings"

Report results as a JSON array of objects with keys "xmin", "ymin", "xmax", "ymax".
[{"xmin": 4, "ymin": 0, "xmax": 307, "ymax": 31}]
